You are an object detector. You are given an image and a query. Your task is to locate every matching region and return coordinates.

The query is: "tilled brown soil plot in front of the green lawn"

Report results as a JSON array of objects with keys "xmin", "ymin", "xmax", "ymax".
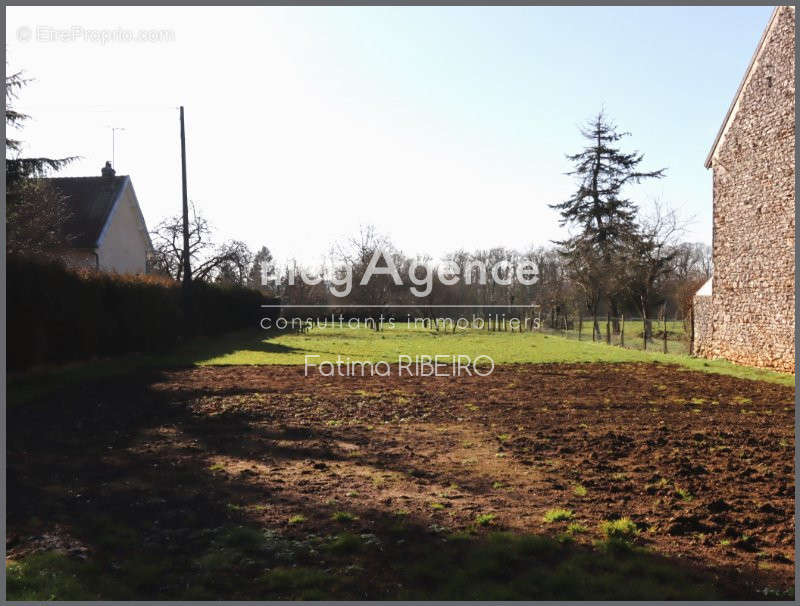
[{"xmin": 8, "ymin": 364, "xmax": 794, "ymax": 591}]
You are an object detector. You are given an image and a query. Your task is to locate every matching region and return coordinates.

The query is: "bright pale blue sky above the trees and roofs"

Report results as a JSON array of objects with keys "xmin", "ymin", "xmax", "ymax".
[{"xmin": 7, "ymin": 7, "xmax": 771, "ymax": 262}]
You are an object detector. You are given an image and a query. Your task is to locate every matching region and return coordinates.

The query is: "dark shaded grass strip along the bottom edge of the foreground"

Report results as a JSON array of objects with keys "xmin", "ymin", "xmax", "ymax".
[{"xmin": 8, "ymin": 525, "xmax": 723, "ymax": 600}]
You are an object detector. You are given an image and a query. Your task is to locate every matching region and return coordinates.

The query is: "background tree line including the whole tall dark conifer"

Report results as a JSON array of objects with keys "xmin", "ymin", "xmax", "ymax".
[{"xmin": 273, "ymin": 112, "xmax": 711, "ymax": 333}]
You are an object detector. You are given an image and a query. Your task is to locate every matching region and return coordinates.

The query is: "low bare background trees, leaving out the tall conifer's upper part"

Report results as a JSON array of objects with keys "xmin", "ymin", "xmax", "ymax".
[{"xmin": 267, "ymin": 226, "xmax": 711, "ymax": 330}]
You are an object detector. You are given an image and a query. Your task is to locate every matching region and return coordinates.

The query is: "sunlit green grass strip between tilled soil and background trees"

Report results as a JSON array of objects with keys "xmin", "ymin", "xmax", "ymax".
[{"xmin": 8, "ymin": 325, "xmax": 794, "ymax": 404}]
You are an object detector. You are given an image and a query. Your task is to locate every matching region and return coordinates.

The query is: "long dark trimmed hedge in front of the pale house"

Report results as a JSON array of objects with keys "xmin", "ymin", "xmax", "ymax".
[{"xmin": 6, "ymin": 257, "xmax": 275, "ymax": 370}]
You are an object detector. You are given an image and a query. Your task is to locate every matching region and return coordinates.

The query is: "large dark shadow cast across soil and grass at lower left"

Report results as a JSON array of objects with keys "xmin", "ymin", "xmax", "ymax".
[{"xmin": 7, "ymin": 370, "xmax": 785, "ymax": 600}]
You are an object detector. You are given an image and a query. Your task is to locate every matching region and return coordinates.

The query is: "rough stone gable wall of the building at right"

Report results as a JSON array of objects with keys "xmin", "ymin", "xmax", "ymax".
[{"xmin": 693, "ymin": 6, "xmax": 795, "ymax": 372}]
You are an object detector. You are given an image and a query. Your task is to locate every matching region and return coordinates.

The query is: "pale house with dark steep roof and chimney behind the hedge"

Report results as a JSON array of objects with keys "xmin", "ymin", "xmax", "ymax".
[{"xmin": 46, "ymin": 162, "xmax": 153, "ymax": 274}]
